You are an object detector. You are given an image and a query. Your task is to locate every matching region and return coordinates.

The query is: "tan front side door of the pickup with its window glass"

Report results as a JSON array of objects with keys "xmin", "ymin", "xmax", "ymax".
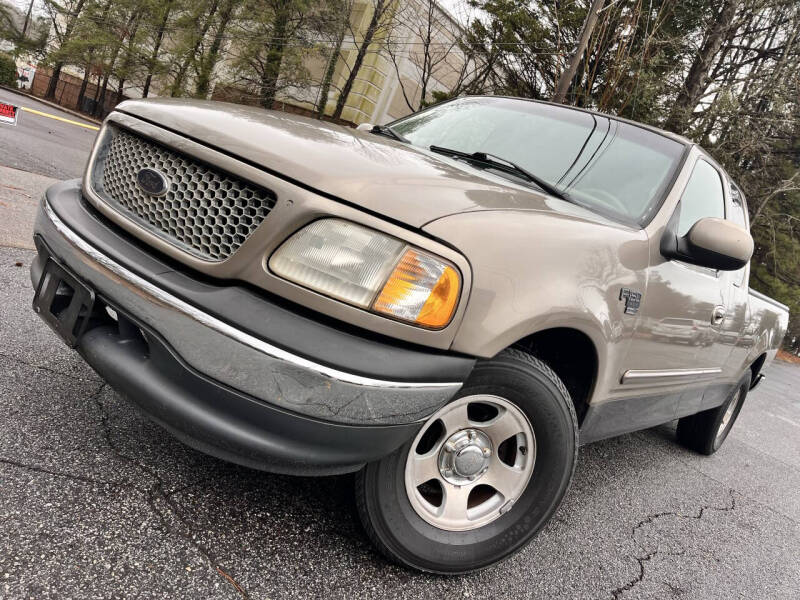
[{"xmin": 621, "ymin": 156, "xmax": 730, "ymax": 422}]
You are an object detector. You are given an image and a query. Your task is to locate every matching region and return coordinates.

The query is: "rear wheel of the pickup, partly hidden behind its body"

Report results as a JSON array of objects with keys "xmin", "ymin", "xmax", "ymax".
[{"xmin": 677, "ymin": 369, "xmax": 752, "ymax": 455}]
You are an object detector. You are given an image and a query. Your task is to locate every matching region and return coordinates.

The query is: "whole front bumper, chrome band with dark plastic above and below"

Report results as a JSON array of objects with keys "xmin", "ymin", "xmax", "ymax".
[{"xmin": 31, "ymin": 182, "xmax": 474, "ymax": 474}]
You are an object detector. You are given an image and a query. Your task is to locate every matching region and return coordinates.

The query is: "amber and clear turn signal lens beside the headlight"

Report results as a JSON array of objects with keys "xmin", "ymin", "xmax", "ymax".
[{"xmin": 372, "ymin": 248, "xmax": 461, "ymax": 329}]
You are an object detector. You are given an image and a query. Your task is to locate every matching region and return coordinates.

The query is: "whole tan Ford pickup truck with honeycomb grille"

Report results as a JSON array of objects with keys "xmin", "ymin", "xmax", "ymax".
[{"xmin": 31, "ymin": 97, "xmax": 788, "ymax": 573}]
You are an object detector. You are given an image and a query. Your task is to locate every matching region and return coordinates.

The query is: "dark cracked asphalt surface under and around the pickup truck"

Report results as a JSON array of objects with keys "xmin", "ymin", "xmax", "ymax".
[{"xmin": 0, "ymin": 109, "xmax": 800, "ymax": 599}]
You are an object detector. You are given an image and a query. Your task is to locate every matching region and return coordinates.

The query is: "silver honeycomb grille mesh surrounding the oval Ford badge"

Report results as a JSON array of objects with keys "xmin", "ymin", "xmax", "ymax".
[{"xmin": 96, "ymin": 129, "xmax": 275, "ymax": 261}]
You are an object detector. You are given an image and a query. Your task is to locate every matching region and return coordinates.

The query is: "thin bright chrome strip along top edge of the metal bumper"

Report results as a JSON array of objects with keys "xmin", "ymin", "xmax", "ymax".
[{"xmin": 44, "ymin": 200, "xmax": 462, "ymax": 390}]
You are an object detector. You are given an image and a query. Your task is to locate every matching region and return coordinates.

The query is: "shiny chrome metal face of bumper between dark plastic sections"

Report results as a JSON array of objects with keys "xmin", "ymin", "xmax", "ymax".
[{"xmin": 32, "ymin": 195, "xmax": 461, "ymax": 425}]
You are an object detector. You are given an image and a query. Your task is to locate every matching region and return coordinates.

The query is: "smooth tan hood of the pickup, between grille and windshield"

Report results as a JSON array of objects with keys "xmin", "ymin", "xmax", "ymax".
[{"xmin": 116, "ymin": 99, "xmax": 620, "ymax": 228}]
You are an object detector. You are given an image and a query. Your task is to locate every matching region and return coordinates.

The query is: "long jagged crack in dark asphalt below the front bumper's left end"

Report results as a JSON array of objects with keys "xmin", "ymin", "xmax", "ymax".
[{"xmin": 90, "ymin": 383, "xmax": 250, "ymax": 599}]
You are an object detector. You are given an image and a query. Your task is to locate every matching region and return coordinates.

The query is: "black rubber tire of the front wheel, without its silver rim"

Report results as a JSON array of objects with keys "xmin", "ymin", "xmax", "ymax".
[{"xmin": 362, "ymin": 353, "xmax": 577, "ymax": 573}]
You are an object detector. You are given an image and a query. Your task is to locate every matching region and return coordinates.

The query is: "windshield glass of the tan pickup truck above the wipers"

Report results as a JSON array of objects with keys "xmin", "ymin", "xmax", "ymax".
[{"xmin": 390, "ymin": 97, "xmax": 684, "ymax": 225}]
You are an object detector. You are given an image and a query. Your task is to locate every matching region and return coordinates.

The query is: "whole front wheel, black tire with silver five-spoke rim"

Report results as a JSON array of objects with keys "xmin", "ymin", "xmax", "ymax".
[{"xmin": 356, "ymin": 350, "xmax": 578, "ymax": 574}]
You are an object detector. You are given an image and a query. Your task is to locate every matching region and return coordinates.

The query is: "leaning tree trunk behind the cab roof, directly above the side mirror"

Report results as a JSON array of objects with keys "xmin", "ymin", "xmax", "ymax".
[{"xmin": 664, "ymin": 0, "xmax": 741, "ymax": 133}]
